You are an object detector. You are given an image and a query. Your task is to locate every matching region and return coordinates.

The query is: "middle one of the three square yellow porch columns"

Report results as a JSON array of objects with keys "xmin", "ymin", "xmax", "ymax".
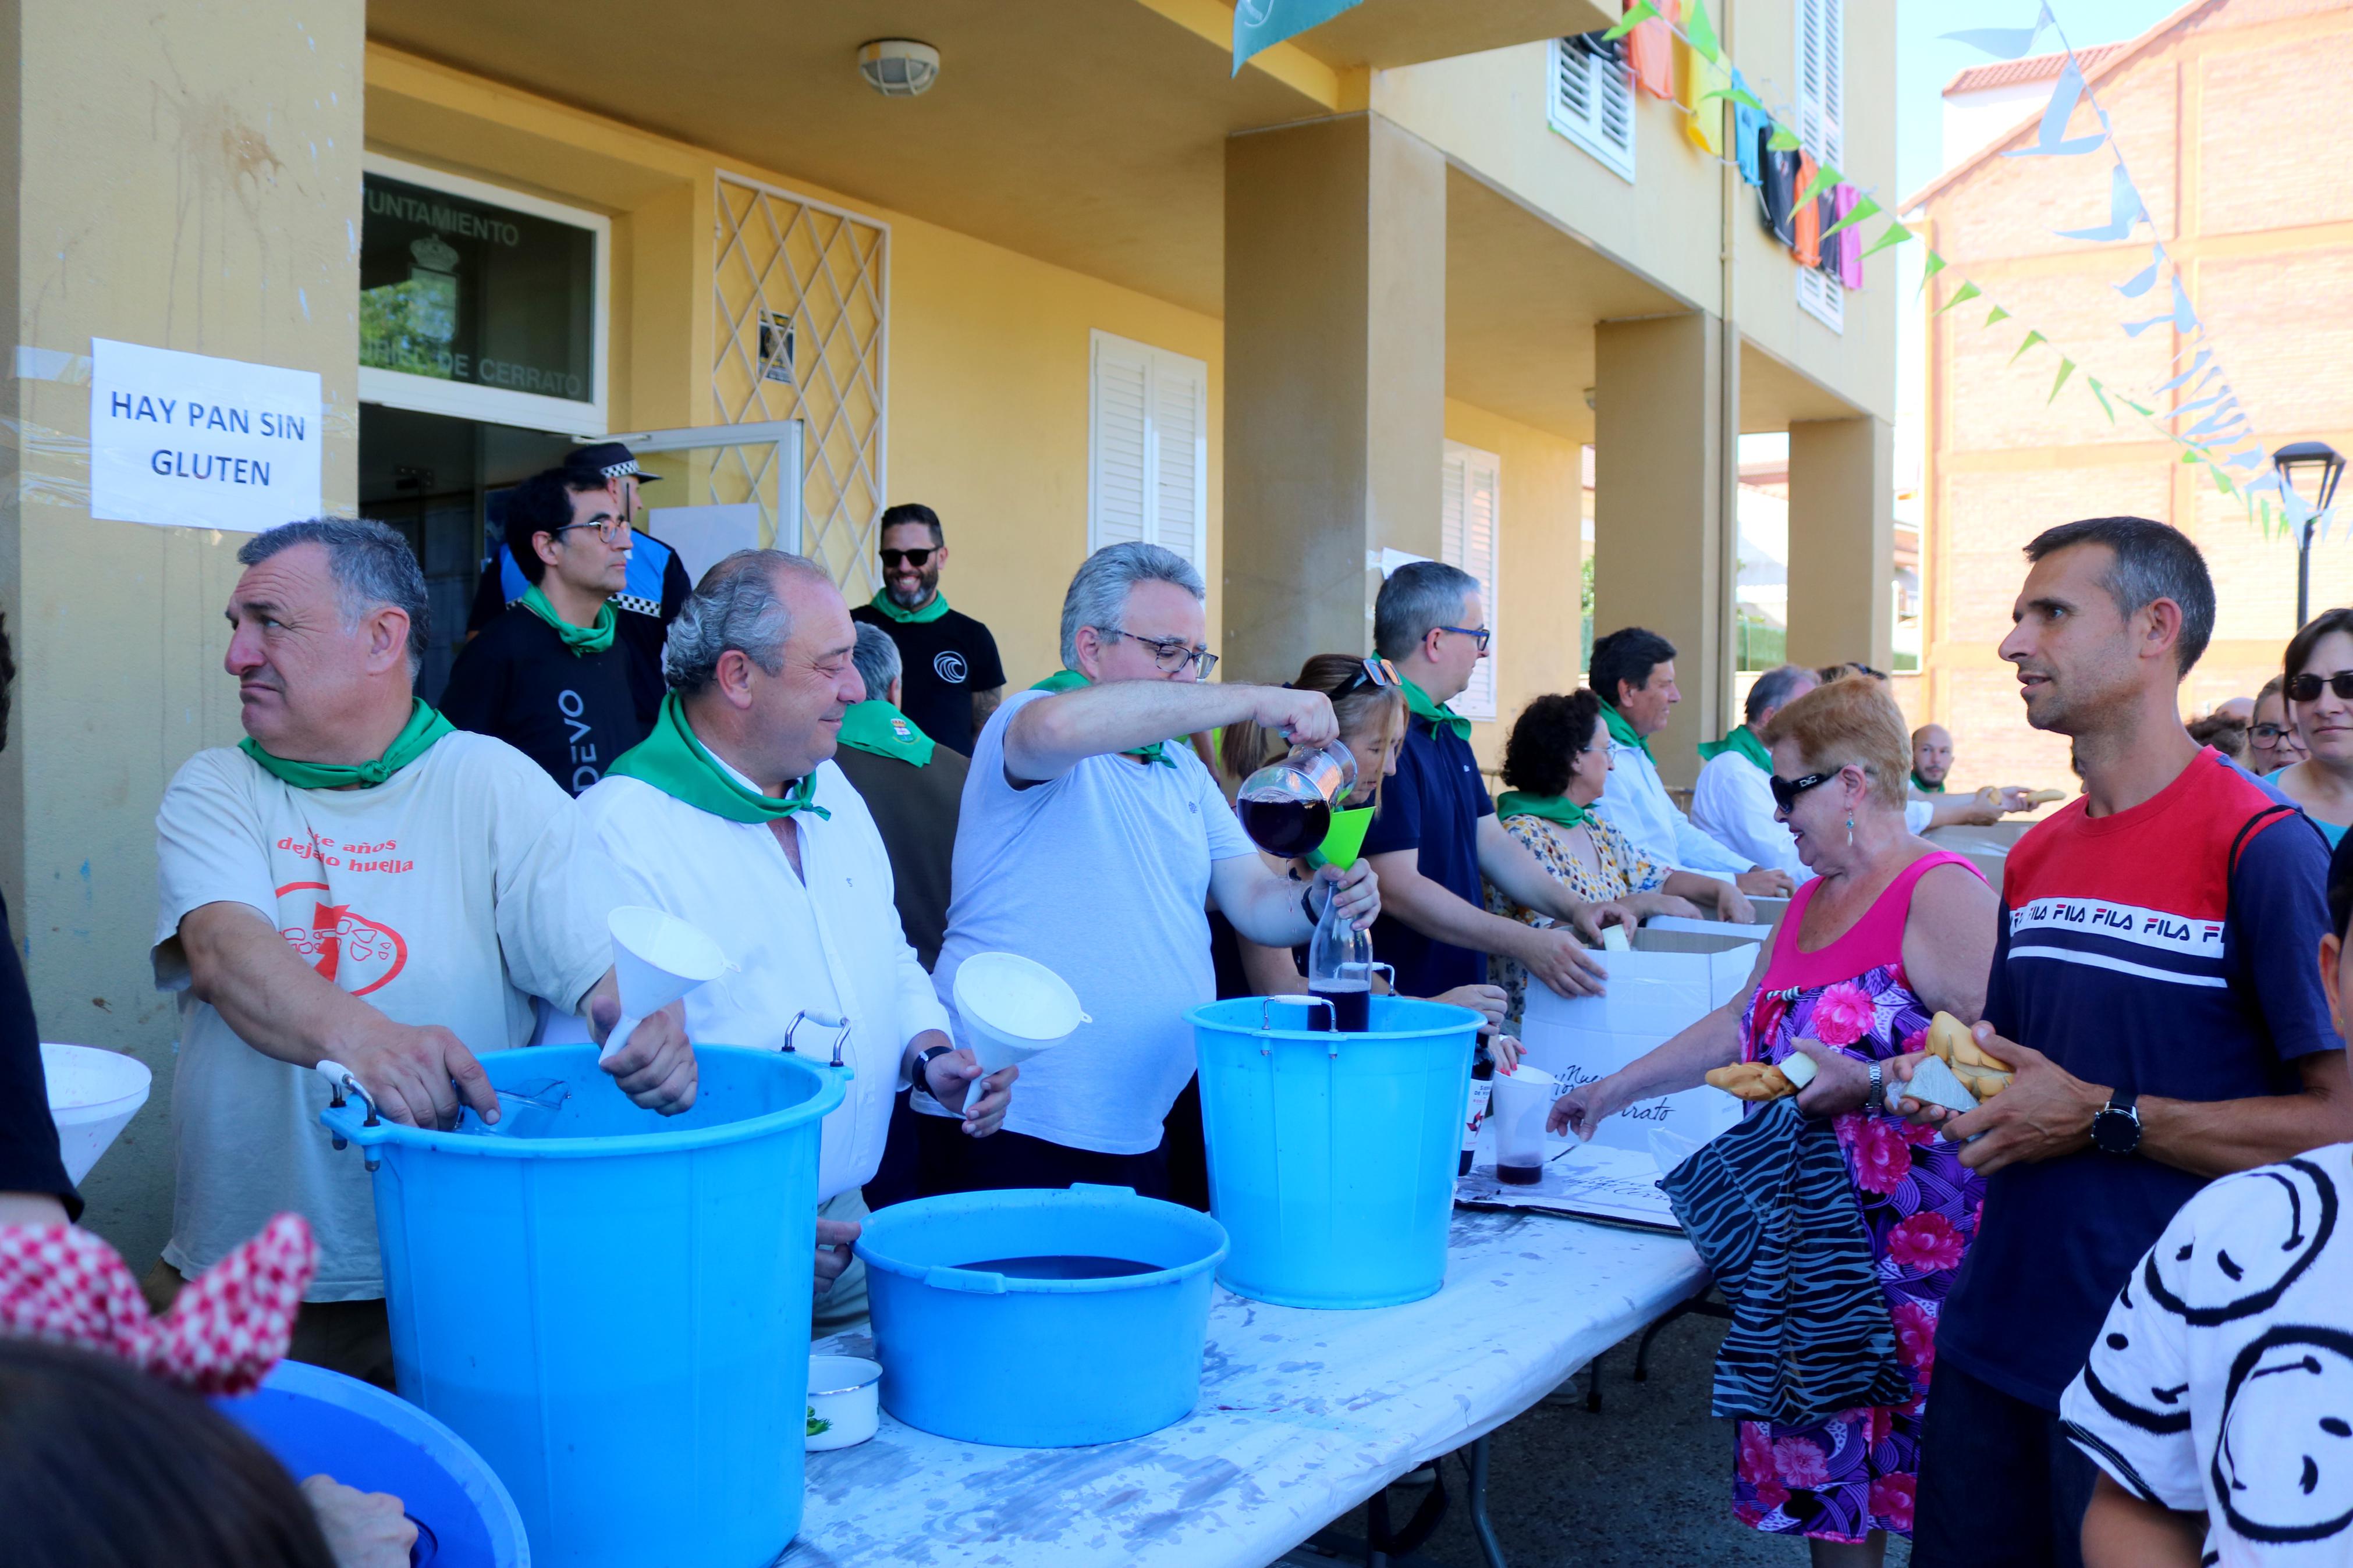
[{"xmin": 1593, "ymin": 310, "xmax": 1732, "ymax": 785}]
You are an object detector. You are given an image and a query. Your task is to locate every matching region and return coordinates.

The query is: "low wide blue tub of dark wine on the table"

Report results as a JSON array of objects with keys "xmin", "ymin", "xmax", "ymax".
[{"xmin": 857, "ymin": 1185, "xmax": 1226, "ymax": 1448}]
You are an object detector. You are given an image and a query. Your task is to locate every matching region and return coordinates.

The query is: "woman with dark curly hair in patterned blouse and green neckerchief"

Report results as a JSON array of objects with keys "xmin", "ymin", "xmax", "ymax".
[{"xmin": 1487, "ymin": 691, "xmax": 1753, "ymax": 1027}]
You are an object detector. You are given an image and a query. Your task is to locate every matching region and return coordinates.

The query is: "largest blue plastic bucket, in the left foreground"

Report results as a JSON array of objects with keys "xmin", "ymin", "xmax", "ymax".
[{"xmin": 320, "ymin": 1044, "xmax": 842, "ymax": 1568}]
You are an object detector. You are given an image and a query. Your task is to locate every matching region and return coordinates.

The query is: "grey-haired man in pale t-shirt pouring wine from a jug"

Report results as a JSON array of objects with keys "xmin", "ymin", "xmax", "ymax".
[{"xmin": 913, "ymin": 543, "xmax": 1381, "ymax": 1197}]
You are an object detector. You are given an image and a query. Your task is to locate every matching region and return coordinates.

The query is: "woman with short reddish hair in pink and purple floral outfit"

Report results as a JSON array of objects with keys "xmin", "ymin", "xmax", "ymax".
[{"xmin": 1553, "ymin": 682, "xmax": 1995, "ymax": 1566}]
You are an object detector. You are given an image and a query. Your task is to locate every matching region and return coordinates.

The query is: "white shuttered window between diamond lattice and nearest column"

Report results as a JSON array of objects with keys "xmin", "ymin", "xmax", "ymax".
[{"xmin": 1087, "ymin": 332, "xmax": 1209, "ymax": 567}]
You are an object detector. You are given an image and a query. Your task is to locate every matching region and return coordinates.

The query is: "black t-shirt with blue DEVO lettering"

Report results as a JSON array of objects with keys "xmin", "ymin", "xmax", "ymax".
[{"xmin": 440, "ymin": 604, "xmax": 659, "ymax": 795}]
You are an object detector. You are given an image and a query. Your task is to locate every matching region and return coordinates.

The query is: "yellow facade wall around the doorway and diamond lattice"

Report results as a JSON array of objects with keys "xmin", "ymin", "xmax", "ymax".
[{"xmin": 367, "ymin": 45, "xmax": 1223, "ymax": 687}]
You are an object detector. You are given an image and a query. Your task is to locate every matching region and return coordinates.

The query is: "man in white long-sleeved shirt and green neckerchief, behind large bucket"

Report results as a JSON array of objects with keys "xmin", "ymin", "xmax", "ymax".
[{"xmin": 581, "ymin": 550, "xmax": 1019, "ymax": 1331}]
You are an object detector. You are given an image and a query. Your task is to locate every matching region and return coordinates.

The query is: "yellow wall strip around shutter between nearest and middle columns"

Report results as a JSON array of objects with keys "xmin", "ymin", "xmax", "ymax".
[{"xmin": 1447, "ymin": 397, "xmax": 1584, "ymax": 771}]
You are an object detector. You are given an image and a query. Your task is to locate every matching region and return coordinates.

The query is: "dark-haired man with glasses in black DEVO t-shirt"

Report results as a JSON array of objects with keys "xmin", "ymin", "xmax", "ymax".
[{"xmin": 440, "ymin": 468, "xmax": 659, "ymax": 795}]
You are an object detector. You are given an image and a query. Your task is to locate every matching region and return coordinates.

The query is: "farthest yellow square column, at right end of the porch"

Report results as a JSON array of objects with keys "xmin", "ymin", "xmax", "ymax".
[{"xmin": 1788, "ymin": 416, "xmax": 1897, "ymax": 670}]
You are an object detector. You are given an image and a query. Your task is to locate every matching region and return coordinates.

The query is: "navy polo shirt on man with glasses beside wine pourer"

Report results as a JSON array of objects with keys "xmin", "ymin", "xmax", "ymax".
[{"xmin": 1365, "ymin": 717, "xmax": 1494, "ymax": 997}]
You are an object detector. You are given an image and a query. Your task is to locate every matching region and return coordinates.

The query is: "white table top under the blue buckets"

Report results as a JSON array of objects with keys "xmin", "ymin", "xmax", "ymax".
[{"xmin": 781, "ymin": 1211, "xmax": 1706, "ymax": 1568}]
